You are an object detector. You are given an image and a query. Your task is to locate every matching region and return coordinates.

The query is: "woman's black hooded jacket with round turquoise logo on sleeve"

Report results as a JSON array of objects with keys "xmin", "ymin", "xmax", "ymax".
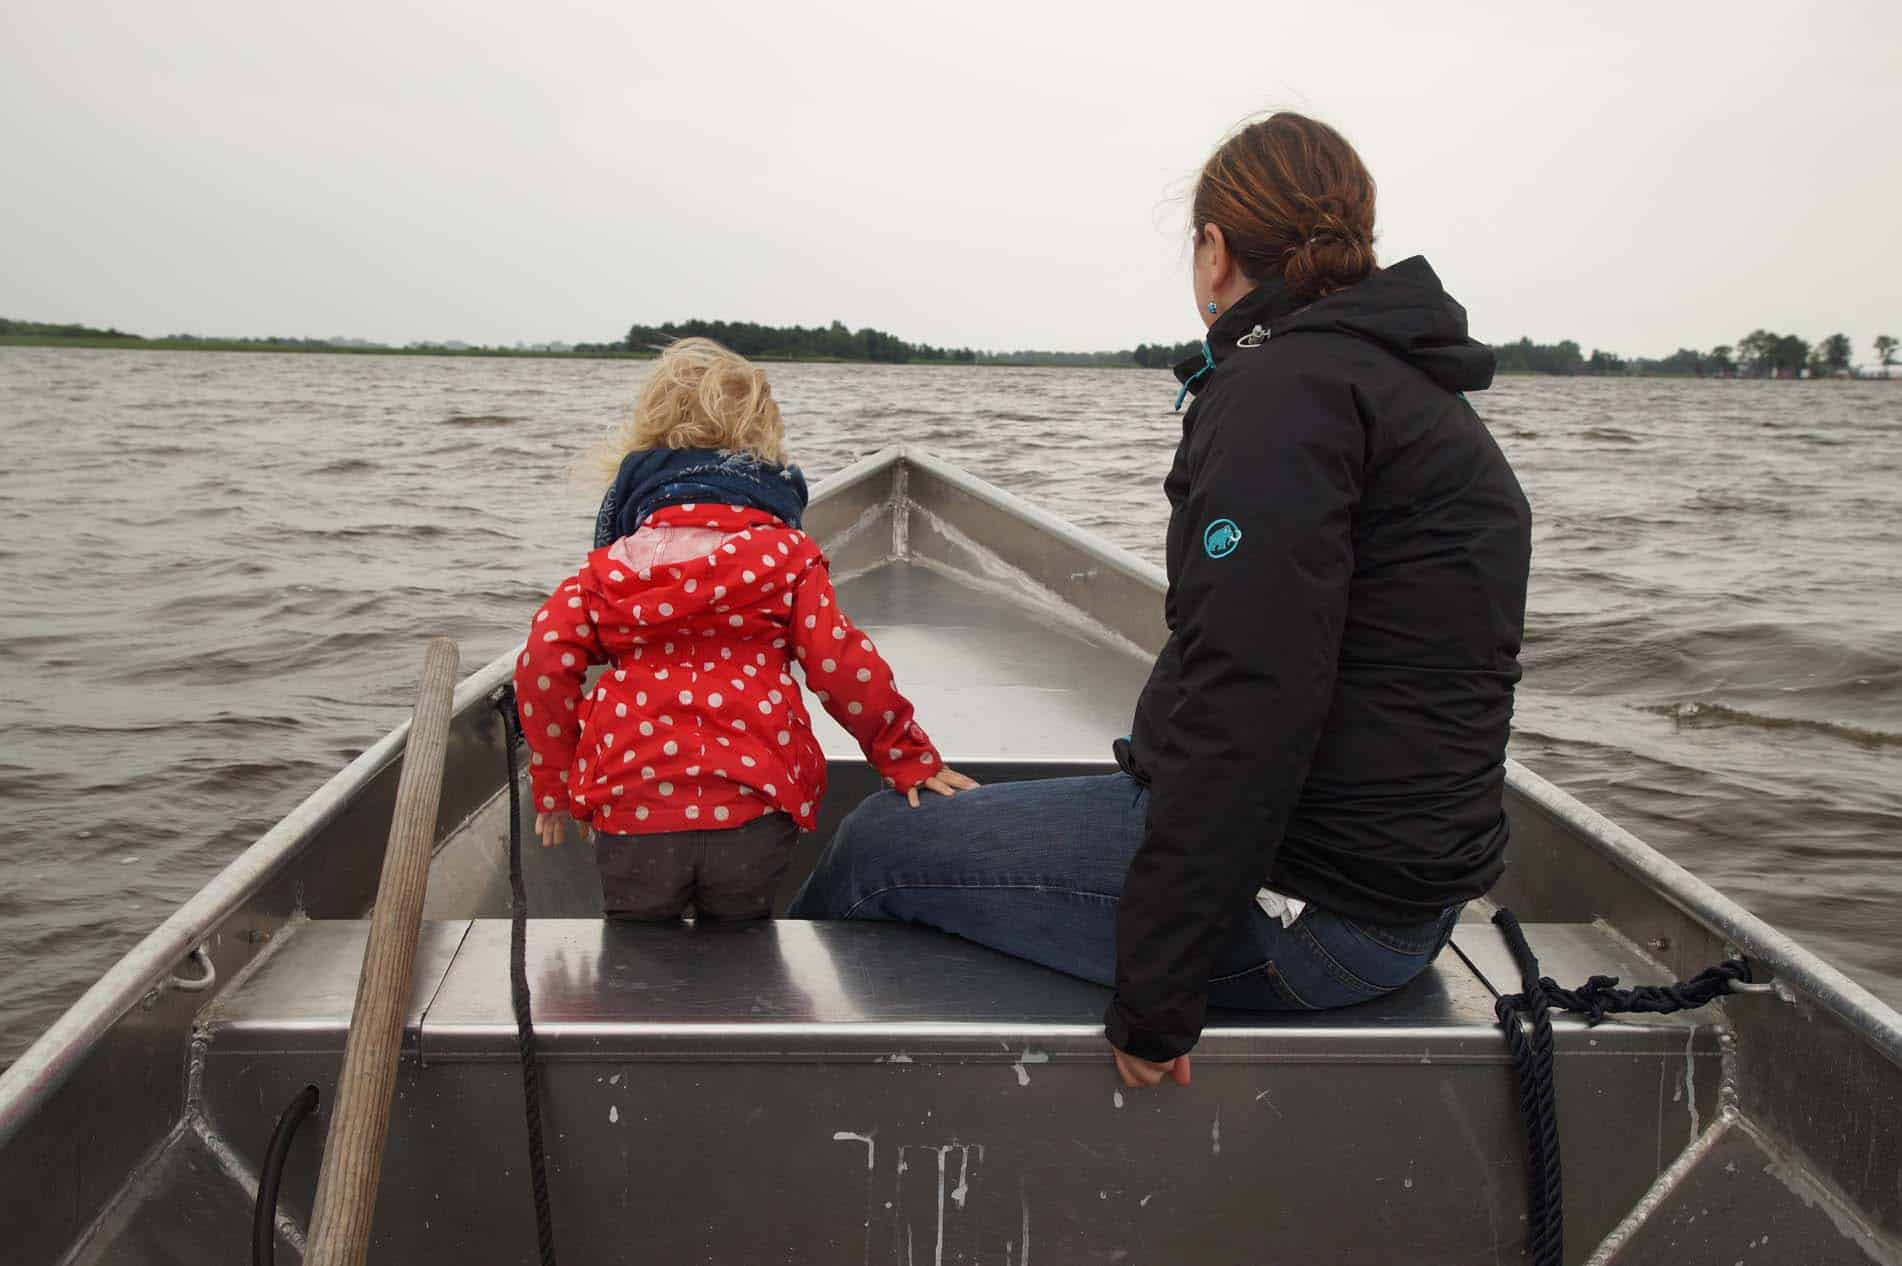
[{"xmin": 1107, "ymin": 259, "xmax": 1531, "ymax": 1061}]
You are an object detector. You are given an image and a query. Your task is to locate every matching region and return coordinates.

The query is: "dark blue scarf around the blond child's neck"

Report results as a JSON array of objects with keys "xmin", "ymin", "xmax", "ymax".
[{"xmin": 595, "ymin": 449, "xmax": 806, "ymax": 549}]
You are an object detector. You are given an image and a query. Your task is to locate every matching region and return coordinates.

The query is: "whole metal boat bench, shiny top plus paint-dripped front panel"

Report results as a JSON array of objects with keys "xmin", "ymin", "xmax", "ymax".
[{"xmin": 202, "ymin": 918, "xmax": 1721, "ymax": 1264}]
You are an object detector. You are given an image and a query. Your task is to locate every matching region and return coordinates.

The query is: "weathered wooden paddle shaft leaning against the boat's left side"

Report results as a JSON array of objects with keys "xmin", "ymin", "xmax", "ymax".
[{"xmin": 304, "ymin": 637, "xmax": 458, "ymax": 1266}]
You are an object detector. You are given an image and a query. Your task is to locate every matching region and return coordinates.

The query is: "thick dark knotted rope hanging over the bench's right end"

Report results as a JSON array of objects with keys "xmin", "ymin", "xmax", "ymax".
[{"xmin": 1493, "ymin": 909, "xmax": 1750, "ymax": 1266}]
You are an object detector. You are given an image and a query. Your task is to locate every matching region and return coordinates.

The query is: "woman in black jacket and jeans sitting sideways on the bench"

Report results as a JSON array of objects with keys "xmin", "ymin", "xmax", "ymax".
[{"xmin": 793, "ymin": 114, "xmax": 1531, "ymax": 1087}]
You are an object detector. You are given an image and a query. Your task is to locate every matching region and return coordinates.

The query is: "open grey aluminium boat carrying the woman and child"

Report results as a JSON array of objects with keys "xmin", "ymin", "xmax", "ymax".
[{"xmin": 0, "ymin": 447, "xmax": 1902, "ymax": 1266}]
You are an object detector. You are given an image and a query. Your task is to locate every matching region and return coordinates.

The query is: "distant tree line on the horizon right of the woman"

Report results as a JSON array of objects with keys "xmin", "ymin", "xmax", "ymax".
[{"xmin": 1493, "ymin": 329, "xmax": 1898, "ymax": 378}]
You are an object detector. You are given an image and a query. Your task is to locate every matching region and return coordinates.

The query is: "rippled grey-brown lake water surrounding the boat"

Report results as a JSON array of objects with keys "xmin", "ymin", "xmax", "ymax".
[{"xmin": 0, "ymin": 348, "xmax": 1902, "ymax": 1059}]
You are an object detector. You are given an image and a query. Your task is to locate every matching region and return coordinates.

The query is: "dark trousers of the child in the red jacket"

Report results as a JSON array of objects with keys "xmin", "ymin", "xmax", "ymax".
[{"xmin": 595, "ymin": 814, "xmax": 799, "ymax": 922}]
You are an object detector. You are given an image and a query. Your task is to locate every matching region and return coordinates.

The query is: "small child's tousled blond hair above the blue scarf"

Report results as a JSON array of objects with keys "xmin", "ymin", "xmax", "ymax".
[{"xmin": 586, "ymin": 338, "xmax": 786, "ymax": 479}]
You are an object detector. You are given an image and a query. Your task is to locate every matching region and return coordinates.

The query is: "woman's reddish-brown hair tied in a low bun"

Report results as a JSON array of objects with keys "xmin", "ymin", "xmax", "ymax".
[{"xmin": 1191, "ymin": 112, "xmax": 1375, "ymax": 302}]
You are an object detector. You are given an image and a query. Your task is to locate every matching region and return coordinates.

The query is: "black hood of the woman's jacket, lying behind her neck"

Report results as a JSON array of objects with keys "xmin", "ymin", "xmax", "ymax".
[{"xmin": 1175, "ymin": 255, "xmax": 1493, "ymax": 392}]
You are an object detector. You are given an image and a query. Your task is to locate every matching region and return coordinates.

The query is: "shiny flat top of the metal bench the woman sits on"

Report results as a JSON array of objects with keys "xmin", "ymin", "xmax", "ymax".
[{"xmin": 205, "ymin": 918, "xmax": 1710, "ymax": 1063}]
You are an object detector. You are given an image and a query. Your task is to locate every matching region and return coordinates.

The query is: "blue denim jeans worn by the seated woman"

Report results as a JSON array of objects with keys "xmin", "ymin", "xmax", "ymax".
[{"xmin": 789, "ymin": 774, "xmax": 1459, "ymax": 1011}]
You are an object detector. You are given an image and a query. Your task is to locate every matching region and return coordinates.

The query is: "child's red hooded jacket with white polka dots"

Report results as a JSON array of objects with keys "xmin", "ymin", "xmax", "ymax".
[{"xmin": 515, "ymin": 506, "xmax": 940, "ymax": 834}]
